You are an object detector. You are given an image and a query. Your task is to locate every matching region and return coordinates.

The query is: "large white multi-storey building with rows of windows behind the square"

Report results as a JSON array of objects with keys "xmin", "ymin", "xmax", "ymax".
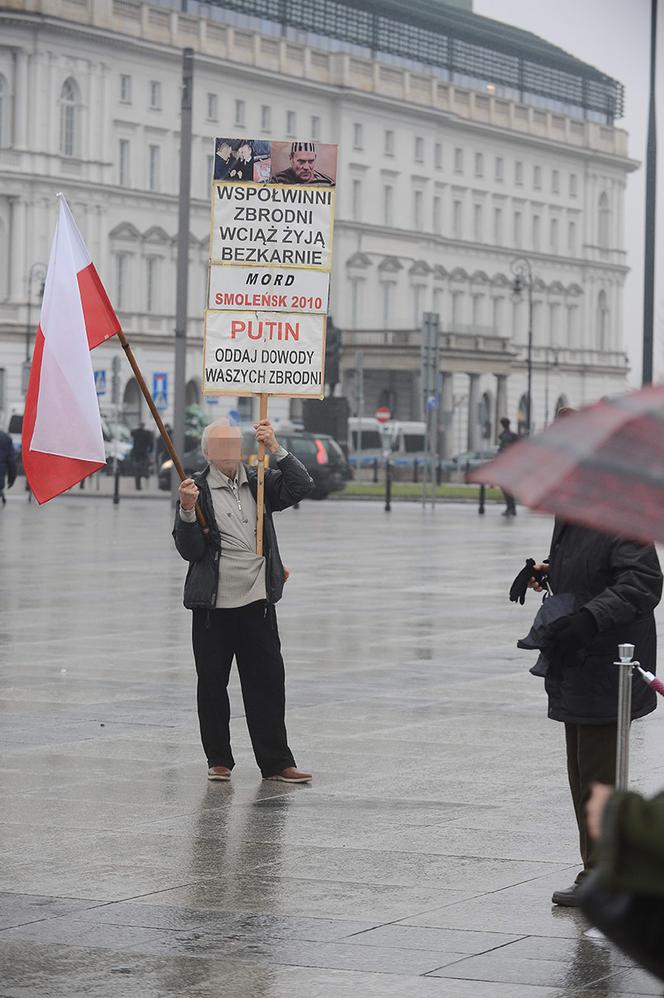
[{"xmin": 0, "ymin": 0, "xmax": 636, "ymax": 451}]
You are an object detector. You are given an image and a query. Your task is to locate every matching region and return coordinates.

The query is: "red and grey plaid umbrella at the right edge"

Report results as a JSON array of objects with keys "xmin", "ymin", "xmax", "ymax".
[{"xmin": 468, "ymin": 386, "xmax": 664, "ymax": 543}]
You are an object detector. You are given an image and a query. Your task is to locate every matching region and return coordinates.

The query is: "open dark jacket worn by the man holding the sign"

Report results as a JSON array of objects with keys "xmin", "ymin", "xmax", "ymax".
[{"xmin": 173, "ymin": 454, "xmax": 314, "ymax": 610}]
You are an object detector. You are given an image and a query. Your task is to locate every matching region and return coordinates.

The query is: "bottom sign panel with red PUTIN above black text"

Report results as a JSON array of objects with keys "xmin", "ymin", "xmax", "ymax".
[{"xmin": 203, "ymin": 311, "xmax": 326, "ymax": 398}]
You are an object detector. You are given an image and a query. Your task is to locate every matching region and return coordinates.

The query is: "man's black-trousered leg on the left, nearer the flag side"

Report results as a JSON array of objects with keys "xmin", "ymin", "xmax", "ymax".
[{"xmin": 192, "ymin": 610, "xmax": 237, "ymax": 769}]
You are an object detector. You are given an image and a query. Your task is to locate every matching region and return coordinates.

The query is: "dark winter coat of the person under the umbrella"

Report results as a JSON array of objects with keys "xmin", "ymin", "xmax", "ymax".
[{"xmin": 545, "ymin": 520, "xmax": 662, "ymax": 724}]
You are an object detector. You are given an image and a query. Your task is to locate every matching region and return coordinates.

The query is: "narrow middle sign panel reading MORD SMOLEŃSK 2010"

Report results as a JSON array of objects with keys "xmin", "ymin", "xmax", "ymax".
[{"xmin": 208, "ymin": 265, "xmax": 330, "ymax": 314}]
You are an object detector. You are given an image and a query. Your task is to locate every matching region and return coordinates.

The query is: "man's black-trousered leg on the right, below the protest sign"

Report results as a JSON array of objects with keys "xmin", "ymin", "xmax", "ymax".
[{"xmin": 237, "ymin": 602, "xmax": 295, "ymax": 776}]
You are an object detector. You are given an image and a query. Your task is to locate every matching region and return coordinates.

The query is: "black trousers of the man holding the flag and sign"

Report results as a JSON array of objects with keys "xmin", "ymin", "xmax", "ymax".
[{"xmin": 192, "ymin": 601, "xmax": 295, "ymax": 776}]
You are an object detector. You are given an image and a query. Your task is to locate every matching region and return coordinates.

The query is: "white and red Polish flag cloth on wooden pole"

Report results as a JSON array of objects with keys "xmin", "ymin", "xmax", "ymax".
[{"xmin": 21, "ymin": 194, "xmax": 120, "ymax": 504}]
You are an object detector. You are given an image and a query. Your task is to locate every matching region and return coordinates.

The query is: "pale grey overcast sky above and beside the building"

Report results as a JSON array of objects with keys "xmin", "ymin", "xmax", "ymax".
[{"xmin": 474, "ymin": 0, "xmax": 664, "ymax": 384}]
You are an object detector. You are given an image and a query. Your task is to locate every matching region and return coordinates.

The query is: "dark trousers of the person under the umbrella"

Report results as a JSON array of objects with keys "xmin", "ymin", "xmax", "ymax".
[{"xmin": 565, "ymin": 724, "xmax": 618, "ymax": 880}]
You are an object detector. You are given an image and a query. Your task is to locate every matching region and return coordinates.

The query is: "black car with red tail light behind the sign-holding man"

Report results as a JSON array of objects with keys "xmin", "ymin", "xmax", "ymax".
[{"xmin": 159, "ymin": 429, "xmax": 351, "ymax": 499}]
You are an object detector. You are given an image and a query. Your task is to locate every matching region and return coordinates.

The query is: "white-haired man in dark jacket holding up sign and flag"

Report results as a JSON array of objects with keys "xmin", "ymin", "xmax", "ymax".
[{"xmin": 173, "ymin": 419, "xmax": 313, "ymax": 783}]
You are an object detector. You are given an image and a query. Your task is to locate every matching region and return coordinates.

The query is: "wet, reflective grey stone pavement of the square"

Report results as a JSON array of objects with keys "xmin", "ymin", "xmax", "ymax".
[{"xmin": 0, "ymin": 493, "xmax": 664, "ymax": 998}]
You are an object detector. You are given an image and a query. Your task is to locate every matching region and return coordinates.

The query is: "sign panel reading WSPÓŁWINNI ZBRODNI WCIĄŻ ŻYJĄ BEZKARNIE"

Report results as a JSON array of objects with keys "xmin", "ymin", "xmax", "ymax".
[{"xmin": 210, "ymin": 183, "xmax": 334, "ymax": 270}]
